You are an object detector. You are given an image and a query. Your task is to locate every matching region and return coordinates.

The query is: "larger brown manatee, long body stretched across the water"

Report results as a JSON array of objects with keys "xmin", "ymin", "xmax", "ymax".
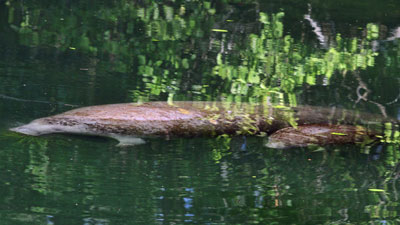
[{"xmin": 11, "ymin": 102, "xmax": 390, "ymax": 145}]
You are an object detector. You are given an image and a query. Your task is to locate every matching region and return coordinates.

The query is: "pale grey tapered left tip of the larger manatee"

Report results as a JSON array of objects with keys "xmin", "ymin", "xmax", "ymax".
[{"xmin": 10, "ymin": 119, "xmax": 57, "ymax": 136}]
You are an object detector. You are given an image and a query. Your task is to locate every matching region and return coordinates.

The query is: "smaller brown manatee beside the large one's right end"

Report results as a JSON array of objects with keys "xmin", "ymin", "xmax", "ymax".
[{"xmin": 267, "ymin": 124, "xmax": 376, "ymax": 148}]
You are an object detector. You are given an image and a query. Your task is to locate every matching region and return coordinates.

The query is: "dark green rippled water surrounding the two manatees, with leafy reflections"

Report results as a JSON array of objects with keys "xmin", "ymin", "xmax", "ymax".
[{"xmin": 0, "ymin": 0, "xmax": 400, "ymax": 225}]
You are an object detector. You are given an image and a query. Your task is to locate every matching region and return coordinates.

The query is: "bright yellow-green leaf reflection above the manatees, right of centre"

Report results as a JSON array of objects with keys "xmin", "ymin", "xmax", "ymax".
[{"xmin": 213, "ymin": 13, "xmax": 377, "ymax": 105}]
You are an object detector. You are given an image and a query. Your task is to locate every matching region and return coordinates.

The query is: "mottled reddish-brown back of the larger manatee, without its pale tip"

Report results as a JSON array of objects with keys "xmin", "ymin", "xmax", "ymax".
[{"xmin": 48, "ymin": 102, "xmax": 282, "ymax": 137}]
